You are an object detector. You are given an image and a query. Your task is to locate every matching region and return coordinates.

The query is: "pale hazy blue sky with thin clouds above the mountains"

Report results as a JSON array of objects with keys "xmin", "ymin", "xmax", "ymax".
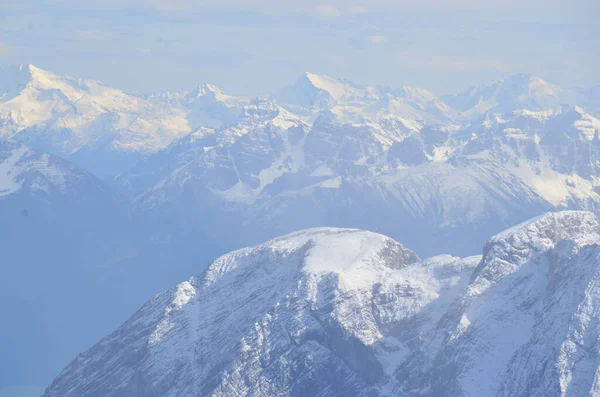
[{"xmin": 0, "ymin": 0, "xmax": 600, "ymax": 94}]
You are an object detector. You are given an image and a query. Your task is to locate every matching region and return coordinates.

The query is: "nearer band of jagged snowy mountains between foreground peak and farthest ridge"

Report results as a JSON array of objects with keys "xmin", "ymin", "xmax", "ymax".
[{"xmin": 121, "ymin": 101, "xmax": 600, "ymax": 256}]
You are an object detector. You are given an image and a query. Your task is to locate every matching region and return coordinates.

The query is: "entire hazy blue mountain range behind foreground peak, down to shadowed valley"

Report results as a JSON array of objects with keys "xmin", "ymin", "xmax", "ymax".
[{"xmin": 0, "ymin": 65, "xmax": 600, "ymax": 389}]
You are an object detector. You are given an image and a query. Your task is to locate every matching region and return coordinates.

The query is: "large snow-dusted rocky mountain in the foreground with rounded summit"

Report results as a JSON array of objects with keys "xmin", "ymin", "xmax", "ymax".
[{"xmin": 44, "ymin": 212, "xmax": 600, "ymax": 397}]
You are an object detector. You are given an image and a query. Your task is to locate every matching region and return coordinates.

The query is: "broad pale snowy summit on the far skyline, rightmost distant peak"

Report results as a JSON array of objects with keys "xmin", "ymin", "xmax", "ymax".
[{"xmin": 442, "ymin": 74, "xmax": 566, "ymax": 119}]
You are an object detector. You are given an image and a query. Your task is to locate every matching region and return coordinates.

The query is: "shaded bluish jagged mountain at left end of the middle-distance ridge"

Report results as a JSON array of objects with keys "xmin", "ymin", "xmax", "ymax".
[{"xmin": 118, "ymin": 98, "xmax": 308, "ymax": 200}]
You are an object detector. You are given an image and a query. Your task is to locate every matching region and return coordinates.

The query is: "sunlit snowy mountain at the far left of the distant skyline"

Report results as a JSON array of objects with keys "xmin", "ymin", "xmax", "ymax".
[{"xmin": 0, "ymin": 65, "xmax": 190, "ymax": 176}]
